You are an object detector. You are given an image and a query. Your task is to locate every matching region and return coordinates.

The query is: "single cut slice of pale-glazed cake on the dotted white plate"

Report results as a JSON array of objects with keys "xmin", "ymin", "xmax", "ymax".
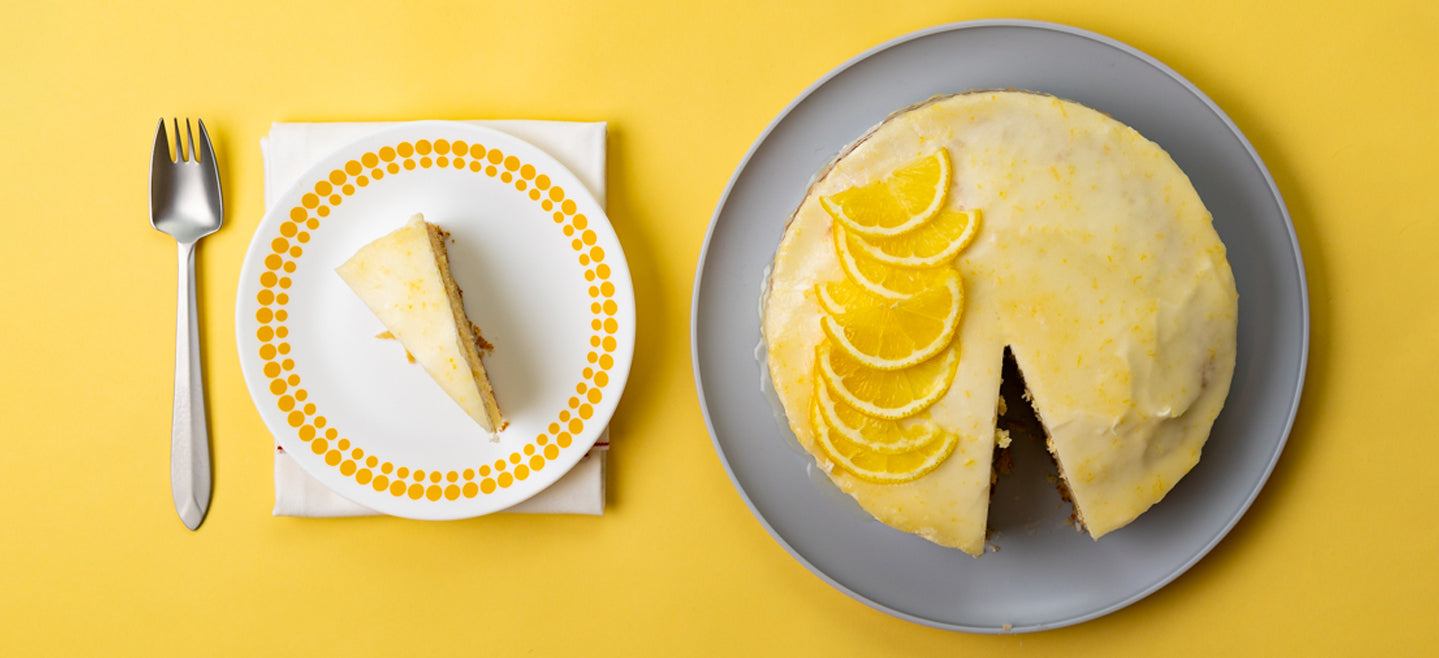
[{"xmin": 335, "ymin": 215, "xmax": 505, "ymax": 433}]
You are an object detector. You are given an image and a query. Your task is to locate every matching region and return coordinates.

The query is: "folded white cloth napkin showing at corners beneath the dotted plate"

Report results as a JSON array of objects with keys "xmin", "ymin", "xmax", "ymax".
[{"xmin": 260, "ymin": 121, "xmax": 610, "ymax": 517}]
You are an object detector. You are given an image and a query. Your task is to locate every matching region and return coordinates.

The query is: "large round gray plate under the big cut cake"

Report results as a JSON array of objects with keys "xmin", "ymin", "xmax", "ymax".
[{"xmin": 691, "ymin": 20, "xmax": 1309, "ymax": 632}]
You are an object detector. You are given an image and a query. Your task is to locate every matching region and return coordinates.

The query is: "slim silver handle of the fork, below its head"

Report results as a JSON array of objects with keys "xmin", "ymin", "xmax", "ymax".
[{"xmin": 170, "ymin": 242, "xmax": 210, "ymax": 530}]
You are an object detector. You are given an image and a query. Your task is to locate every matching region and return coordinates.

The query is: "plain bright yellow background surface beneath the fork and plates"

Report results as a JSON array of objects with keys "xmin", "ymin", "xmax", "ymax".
[{"xmin": 0, "ymin": 0, "xmax": 1439, "ymax": 655}]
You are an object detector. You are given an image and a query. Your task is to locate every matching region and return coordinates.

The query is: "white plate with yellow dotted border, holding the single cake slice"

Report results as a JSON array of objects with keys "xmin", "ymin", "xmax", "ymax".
[{"xmin": 236, "ymin": 121, "xmax": 635, "ymax": 520}]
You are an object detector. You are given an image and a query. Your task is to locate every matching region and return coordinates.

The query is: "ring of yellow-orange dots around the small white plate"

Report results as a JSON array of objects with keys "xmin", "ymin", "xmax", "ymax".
[{"xmin": 255, "ymin": 140, "xmax": 619, "ymax": 501}]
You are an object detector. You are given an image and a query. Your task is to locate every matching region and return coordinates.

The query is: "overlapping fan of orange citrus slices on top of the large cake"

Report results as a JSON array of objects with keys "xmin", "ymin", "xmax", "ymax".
[{"xmin": 810, "ymin": 148, "xmax": 980, "ymax": 484}]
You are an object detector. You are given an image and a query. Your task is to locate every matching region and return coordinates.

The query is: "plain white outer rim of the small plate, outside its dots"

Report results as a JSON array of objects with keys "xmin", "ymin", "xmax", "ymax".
[{"xmin": 235, "ymin": 120, "xmax": 639, "ymax": 521}]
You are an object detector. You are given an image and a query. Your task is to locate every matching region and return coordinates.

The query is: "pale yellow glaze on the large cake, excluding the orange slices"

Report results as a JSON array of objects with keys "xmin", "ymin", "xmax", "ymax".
[{"xmin": 763, "ymin": 92, "xmax": 1238, "ymax": 554}]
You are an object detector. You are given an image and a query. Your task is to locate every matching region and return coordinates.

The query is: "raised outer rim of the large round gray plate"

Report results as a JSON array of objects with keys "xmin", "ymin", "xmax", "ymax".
[{"xmin": 689, "ymin": 19, "xmax": 1311, "ymax": 635}]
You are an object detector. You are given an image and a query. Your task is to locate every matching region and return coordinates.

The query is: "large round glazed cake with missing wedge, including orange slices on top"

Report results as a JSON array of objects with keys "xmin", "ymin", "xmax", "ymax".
[{"xmin": 763, "ymin": 92, "xmax": 1238, "ymax": 554}]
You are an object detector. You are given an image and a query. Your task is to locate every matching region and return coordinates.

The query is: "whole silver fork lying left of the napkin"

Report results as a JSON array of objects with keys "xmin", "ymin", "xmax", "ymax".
[{"xmin": 150, "ymin": 118, "xmax": 224, "ymax": 530}]
